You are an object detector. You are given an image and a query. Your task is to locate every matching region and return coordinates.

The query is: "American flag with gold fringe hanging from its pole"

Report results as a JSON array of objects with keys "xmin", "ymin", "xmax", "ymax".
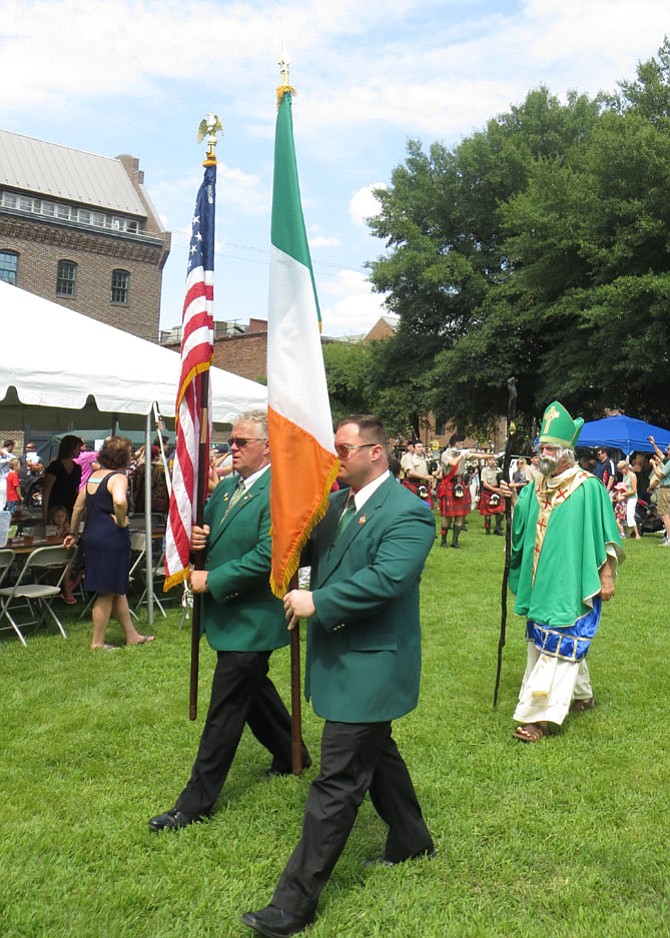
[{"xmin": 164, "ymin": 163, "xmax": 216, "ymax": 590}]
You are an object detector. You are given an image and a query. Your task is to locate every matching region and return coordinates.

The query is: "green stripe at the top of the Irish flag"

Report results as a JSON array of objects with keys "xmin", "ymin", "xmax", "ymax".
[{"xmin": 271, "ymin": 91, "xmax": 321, "ymax": 322}]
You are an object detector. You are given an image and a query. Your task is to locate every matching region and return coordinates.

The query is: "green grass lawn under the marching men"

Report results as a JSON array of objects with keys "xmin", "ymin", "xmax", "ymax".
[{"xmin": 0, "ymin": 515, "xmax": 670, "ymax": 938}]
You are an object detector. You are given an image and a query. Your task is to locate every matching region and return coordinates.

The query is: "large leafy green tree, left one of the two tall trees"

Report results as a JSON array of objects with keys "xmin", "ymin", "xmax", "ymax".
[{"xmin": 370, "ymin": 88, "xmax": 601, "ymax": 427}]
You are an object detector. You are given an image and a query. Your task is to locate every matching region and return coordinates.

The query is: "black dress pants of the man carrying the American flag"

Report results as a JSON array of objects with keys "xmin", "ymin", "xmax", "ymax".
[{"xmin": 175, "ymin": 651, "xmax": 309, "ymax": 818}]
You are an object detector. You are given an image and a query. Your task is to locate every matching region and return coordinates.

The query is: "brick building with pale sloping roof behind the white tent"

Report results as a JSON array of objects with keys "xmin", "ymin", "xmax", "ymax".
[{"xmin": 0, "ymin": 130, "xmax": 170, "ymax": 342}]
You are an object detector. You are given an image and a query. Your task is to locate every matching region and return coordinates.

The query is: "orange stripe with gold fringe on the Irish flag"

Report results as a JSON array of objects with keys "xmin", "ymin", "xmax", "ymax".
[{"xmin": 268, "ymin": 407, "xmax": 339, "ymax": 598}]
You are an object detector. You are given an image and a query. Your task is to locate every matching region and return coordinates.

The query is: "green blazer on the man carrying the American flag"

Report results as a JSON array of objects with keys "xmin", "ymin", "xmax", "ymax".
[{"xmin": 202, "ymin": 469, "xmax": 289, "ymax": 651}]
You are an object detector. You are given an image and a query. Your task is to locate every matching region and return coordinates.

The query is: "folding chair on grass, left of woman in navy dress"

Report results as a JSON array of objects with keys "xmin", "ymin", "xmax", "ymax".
[{"xmin": 0, "ymin": 546, "xmax": 72, "ymax": 646}]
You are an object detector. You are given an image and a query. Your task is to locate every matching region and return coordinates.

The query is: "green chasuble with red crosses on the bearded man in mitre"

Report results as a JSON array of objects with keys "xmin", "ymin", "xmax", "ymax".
[{"xmin": 509, "ymin": 468, "xmax": 624, "ymax": 628}]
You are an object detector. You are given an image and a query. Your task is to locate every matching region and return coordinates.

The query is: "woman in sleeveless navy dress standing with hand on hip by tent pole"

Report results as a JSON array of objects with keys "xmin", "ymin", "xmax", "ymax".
[{"xmin": 63, "ymin": 436, "xmax": 155, "ymax": 651}]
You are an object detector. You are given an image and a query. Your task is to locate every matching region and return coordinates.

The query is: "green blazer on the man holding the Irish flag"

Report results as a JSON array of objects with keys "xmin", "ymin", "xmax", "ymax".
[{"xmin": 305, "ymin": 477, "xmax": 435, "ymax": 723}]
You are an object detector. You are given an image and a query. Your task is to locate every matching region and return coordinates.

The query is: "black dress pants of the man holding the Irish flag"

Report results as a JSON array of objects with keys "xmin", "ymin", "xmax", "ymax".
[{"xmin": 272, "ymin": 721, "xmax": 433, "ymax": 920}]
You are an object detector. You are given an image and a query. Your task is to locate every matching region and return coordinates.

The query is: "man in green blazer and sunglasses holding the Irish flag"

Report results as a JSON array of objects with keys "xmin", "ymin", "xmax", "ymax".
[{"xmin": 242, "ymin": 415, "xmax": 435, "ymax": 938}]
